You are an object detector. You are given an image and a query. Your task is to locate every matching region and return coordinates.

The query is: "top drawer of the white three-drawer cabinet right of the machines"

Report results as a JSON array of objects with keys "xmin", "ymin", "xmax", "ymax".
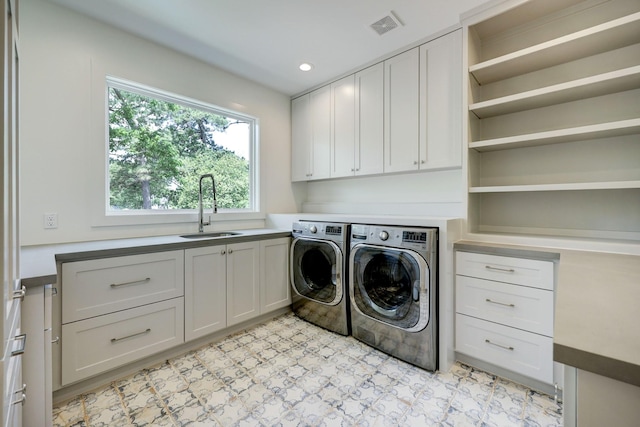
[{"xmin": 456, "ymin": 252, "xmax": 553, "ymax": 291}]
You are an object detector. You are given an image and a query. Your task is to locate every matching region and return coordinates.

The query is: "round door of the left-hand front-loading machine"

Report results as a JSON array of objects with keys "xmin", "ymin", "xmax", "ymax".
[{"xmin": 291, "ymin": 237, "xmax": 343, "ymax": 305}]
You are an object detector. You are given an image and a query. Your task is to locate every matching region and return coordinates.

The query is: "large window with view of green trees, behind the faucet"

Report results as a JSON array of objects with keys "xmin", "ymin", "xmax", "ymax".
[{"xmin": 107, "ymin": 78, "xmax": 256, "ymax": 214}]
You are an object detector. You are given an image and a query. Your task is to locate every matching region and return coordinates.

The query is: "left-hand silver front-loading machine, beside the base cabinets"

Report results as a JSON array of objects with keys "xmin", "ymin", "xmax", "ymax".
[{"xmin": 290, "ymin": 221, "xmax": 351, "ymax": 335}]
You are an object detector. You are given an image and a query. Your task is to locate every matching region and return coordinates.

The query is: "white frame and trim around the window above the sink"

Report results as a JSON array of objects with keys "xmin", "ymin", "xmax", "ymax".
[{"xmin": 92, "ymin": 75, "xmax": 265, "ymax": 227}]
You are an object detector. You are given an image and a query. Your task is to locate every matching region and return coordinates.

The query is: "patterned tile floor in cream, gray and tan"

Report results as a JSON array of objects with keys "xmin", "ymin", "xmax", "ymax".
[{"xmin": 53, "ymin": 314, "xmax": 562, "ymax": 427}]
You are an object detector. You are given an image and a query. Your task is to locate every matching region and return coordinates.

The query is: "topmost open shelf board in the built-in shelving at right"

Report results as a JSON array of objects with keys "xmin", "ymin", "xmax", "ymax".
[{"xmin": 469, "ymin": 12, "xmax": 640, "ymax": 85}]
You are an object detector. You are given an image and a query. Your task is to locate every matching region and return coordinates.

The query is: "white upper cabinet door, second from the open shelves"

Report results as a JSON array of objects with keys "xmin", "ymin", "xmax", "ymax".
[{"xmin": 384, "ymin": 48, "xmax": 420, "ymax": 172}]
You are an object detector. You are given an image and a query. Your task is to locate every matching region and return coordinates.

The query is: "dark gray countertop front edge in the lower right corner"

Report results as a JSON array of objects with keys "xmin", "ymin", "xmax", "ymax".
[{"xmin": 553, "ymin": 343, "xmax": 640, "ymax": 387}]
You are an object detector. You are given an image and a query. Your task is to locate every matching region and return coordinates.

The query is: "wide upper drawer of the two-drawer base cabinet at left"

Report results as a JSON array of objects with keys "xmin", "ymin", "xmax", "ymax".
[{"xmin": 62, "ymin": 251, "xmax": 184, "ymax": 324}]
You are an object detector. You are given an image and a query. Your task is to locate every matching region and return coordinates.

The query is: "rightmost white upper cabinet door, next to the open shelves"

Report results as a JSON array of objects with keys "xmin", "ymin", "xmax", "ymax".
[{"xmin": 420, "ymin": 30, "xmax": 462, "ymax": 169}]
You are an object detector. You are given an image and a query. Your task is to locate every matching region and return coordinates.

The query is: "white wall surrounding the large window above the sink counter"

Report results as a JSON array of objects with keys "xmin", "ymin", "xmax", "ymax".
[{"xmin": 20, "ymin": 0, "xmax": 296, "ymax": 246}]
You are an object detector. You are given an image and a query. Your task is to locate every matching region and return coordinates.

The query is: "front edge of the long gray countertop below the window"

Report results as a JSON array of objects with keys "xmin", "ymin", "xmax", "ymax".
[{"xmin": 56, "ymin": 231, "xmax": 291, "ymax": 262}]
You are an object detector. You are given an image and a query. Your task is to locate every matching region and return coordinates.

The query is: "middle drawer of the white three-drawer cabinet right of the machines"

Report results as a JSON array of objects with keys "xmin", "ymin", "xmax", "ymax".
[{"xmin": 456, "ymin": 276, "xmax": 553, "ymax": 337}]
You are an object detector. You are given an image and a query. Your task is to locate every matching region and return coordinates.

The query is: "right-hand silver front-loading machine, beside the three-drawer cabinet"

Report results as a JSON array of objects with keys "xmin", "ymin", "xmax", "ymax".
[{"xmin": 349, "ymin": 224, "xmax": 438, "ymax": 371}]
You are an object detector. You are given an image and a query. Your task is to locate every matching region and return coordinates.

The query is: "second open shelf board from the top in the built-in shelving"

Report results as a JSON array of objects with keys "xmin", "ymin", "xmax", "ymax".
[{"xmin": 469, "ymin": 65, "xmax": 640, "ymax": 119}]
